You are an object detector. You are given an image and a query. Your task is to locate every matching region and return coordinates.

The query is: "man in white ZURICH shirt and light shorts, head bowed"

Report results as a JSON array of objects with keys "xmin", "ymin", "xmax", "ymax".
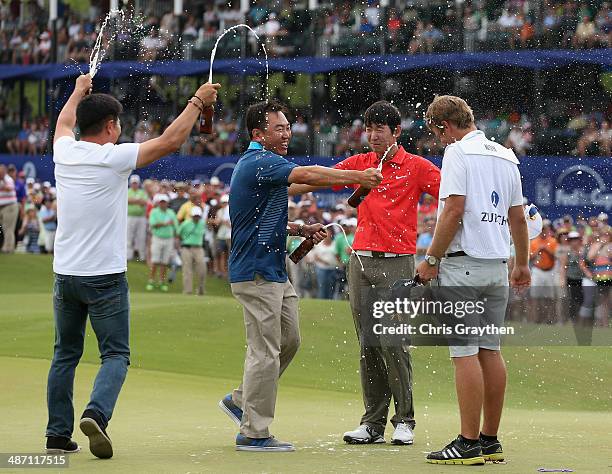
[{"xmin": 417, "ymin": 96, "xmax": 530, "ymax": 464}]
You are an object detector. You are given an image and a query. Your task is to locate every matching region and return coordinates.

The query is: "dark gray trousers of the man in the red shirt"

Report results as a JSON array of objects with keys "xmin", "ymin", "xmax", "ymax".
[{"xmin": 348, "ymin": 254, "xmax": 415, "ymax": 434}]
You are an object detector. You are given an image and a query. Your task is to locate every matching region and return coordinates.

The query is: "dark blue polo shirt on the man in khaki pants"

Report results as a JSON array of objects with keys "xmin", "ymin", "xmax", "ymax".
[{"xmin": 229, "ymin": 142, "xmax": 297, "ymax": 283}]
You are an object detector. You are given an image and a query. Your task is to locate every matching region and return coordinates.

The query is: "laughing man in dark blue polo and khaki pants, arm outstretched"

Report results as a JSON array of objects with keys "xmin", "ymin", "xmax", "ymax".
[{"xmin": 219, "ymin": 101, "xmax": 382, "ymax": 451}]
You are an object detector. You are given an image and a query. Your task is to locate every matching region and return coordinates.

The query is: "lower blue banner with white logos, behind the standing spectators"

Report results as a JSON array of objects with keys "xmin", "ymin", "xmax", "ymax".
[{"xmin": 0, "ymin": 155, "xmax": 612, "ymax": 219}]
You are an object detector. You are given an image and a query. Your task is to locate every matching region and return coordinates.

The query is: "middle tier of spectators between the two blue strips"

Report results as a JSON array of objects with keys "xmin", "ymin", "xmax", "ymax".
[{"xmin": 0, "ymin": 102, "xmax": 612, "ymax": 157}]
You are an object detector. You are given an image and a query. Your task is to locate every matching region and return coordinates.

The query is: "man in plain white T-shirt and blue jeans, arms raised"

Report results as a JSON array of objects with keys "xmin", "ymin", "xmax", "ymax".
[{"xmin": 46, "ymin": 74, "xmax": 220, "ymax": 458}]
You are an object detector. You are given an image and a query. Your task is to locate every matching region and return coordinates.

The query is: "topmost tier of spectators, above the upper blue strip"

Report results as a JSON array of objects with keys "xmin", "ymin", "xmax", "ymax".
[{"xmin": 0, "ymin": 0, "xmax": 612, "ymax": 64}]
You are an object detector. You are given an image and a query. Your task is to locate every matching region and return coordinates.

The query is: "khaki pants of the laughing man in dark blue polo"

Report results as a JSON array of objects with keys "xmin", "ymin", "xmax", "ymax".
[{"xmin": 232, "ymin": 275, "xmax": 300, "ymax": 438}]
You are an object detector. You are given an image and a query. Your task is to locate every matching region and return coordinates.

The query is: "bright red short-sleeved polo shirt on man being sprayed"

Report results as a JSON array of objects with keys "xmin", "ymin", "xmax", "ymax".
[{"xmin": 334, "ymin": 146, "xmax": 440, "ymax": 254}]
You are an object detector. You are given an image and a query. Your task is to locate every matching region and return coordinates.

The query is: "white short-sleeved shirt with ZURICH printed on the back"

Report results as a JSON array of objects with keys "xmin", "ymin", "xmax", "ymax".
[{"xmin": 438, "ymin": 130, "xmax": 523, "ymax": 259}]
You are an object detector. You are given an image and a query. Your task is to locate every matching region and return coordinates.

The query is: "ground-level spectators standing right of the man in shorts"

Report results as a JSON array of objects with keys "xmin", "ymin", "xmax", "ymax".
[{"xmin": 508, "ymin": 212, "xmax": 612, "ymax": 336}]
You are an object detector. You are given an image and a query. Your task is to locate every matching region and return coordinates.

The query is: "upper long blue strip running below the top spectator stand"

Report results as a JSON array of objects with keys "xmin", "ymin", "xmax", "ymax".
[{"xmin": 0, "ymin": 48, "xmax": 612, "ymax": 80}]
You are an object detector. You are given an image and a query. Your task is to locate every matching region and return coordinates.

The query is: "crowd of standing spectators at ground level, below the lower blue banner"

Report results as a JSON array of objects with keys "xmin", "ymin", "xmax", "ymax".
[{"xmin": 0, "ymin": 165, "xmax": 612, "ymax": 334}]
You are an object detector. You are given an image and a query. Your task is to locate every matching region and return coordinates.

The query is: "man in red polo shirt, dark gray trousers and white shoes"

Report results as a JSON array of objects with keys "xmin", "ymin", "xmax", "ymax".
[{"xmin": 289, "ymin": 101, "xmax": 440, "ymax": 445}]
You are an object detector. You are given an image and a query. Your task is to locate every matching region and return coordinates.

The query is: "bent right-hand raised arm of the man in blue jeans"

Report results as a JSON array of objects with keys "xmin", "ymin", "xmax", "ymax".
[{"xmin": 136, "ymin": 82, "xmax": 221, "ymax": 168}]
